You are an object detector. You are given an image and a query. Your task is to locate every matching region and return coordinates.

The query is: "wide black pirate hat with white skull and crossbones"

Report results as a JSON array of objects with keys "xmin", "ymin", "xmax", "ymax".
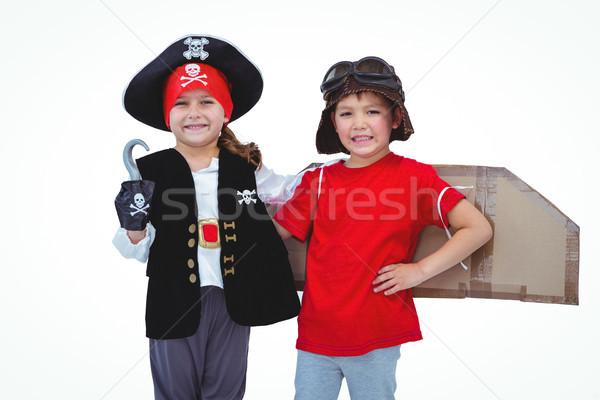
[{"xmin": 123, "ymin": 35, "xmax": 263, "ymax": 131}]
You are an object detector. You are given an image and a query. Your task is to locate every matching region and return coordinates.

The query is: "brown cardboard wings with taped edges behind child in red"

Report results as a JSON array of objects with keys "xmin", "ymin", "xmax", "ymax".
[{"xmin": 270, "ymin": 164, "xmax": 579, "ymax": 305}]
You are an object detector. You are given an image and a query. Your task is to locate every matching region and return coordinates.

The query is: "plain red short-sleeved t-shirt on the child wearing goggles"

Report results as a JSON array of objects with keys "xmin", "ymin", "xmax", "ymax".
[{"xmin": 275, "ymin": 153, "xmax": 464, "ymax": 356}]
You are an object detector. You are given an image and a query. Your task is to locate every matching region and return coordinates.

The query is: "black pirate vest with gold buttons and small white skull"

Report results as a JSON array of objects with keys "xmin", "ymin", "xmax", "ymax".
[{"xmin": 137, "ymin": 149, "xmax": 300, "ymax": 339}]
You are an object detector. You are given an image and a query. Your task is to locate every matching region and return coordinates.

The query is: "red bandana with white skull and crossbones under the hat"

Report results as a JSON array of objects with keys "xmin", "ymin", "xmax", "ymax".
[{"xmin": 163, "ymin": 63, "xmax": 233, "ymax": 129}]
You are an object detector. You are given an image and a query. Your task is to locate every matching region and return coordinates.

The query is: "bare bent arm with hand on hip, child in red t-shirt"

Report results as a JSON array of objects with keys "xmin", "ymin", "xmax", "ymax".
[{"xmin": 373, "ymin": 199, "xmax": 492, "ymax": 296}]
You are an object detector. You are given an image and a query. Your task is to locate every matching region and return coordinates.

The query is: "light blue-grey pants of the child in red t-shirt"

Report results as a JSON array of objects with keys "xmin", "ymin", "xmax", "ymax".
[{"xmin": 295, "ymin": 346, "xmax": 400, "ymax": 400}]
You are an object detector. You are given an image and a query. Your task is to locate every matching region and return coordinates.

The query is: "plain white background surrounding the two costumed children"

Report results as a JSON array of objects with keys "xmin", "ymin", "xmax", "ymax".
[{"xmin": 0, "ymin": 0, "xmax": 600, "ymax": 400}]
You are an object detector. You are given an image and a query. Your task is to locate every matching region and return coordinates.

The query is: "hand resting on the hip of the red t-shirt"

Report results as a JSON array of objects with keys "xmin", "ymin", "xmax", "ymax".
[{"xmin": 373, "ymin": 264, "xmax": 425, "ymax": 296}]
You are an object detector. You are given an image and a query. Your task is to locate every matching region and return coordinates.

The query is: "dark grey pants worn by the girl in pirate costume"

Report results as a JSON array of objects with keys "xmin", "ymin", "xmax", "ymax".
[{"xmin": 150, "ymin": 286, "xmax": 250, "ymax": 400}]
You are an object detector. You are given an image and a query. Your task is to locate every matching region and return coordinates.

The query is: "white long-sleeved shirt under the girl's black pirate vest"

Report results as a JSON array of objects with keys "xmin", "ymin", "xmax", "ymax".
[{"xmin": 113, "ymin": 158, "xmax": 303, "ymax": 288}]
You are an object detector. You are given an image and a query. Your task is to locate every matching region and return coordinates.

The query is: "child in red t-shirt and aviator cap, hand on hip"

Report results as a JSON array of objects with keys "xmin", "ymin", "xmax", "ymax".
[{"xmin": 275, "ymin": 57, "xmax": 492, "ymax": 400}]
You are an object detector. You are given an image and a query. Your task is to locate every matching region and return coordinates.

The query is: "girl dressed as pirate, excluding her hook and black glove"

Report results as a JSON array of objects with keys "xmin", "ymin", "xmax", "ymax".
[{"xmin": 113, "ymin": 35, "xmax": 300, "ymax": 400}]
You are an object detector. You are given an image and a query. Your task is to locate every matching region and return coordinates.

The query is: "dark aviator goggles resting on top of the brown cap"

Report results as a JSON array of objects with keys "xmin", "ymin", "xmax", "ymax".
[{"xmin": 321, "ymin": 57, "xmax": 405, "ymax": 101}]
